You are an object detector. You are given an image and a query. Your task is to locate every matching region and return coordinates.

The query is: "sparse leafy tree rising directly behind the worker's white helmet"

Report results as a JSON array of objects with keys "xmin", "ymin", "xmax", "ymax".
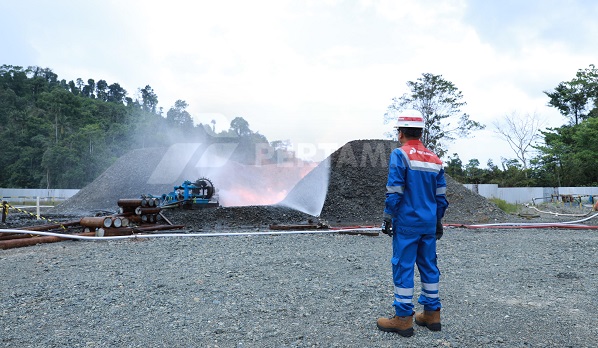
[{"xmin": 384, "ymin": 73, "xmax": 484, "ymax": 157}]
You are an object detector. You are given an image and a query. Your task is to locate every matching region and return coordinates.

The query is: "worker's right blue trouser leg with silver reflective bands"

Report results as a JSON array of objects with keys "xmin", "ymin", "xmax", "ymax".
[{"xmin": 416, "ymin": 234, "xmax": 442, "ymax": 311}]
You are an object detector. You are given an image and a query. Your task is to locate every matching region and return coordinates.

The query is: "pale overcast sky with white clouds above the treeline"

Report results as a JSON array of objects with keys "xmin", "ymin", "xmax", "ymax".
[{"xmin": 0, "ymin": 0, "xmax": 598, "ymax": 167}]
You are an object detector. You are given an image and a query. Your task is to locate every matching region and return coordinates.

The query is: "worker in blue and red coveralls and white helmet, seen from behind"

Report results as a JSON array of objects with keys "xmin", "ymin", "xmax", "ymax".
[{"xmin": 377, "ymin": 112, "xmax": 448, "ymax": 337}]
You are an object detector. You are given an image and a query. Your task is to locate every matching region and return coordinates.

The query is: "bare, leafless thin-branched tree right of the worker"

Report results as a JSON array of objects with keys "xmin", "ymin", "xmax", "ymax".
[{"xmin": 493, "ymin": 111, "xmax": 544, "ymax": 169}]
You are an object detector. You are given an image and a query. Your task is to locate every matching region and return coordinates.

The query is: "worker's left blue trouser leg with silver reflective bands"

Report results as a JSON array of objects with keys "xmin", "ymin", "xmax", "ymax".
[{"xmin": 392, "ymin": 233, "xmax": 420, "ymax": 317}]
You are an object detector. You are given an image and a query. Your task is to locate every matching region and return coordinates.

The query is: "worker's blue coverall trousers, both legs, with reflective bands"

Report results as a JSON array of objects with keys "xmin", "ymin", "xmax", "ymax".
[{"xmin": 391, "ymin": 231, "xmax": 441, "ymax": 316}]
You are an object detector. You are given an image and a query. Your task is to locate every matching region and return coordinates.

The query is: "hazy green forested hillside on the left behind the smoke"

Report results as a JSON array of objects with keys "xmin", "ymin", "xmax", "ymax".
[{"xmin": 0, "ymin": 65, "xmax": 274, "ymax": 189}]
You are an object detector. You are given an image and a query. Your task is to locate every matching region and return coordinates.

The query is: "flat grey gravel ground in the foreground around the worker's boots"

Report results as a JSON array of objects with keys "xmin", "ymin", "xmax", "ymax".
[{"xmin": 0, "ymin": 216, "xmax": 598, "ymax": 347}]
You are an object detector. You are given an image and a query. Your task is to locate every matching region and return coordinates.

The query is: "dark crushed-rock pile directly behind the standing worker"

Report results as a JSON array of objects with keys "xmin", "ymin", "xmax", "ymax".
[{"xmin": 289, "ymin": 140, "xmax": 509, "ymax": 224}]
